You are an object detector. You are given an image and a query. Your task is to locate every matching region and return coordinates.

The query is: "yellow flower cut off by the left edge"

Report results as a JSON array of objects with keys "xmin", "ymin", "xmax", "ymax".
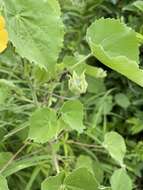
[{"xmin": 0, "ymin": 16, "xmax": 8, "ymax": 53}]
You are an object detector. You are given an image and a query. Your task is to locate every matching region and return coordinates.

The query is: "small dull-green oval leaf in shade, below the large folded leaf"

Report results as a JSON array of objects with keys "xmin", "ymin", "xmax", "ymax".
[{"xmin": 115, "ymin": 93, "xmax": 130, "ymax": 108}]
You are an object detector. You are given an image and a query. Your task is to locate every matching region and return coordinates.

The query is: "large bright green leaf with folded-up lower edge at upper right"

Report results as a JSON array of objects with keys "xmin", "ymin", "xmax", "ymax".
[{"xmin": 87, "ymin": 18, "xmax": 143, "ymax": 86}]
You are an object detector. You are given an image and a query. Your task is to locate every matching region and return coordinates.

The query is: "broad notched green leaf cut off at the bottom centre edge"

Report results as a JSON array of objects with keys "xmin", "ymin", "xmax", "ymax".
[{"xmin": 41, "ymin": 168, "xmax": 98, "ymax": 190}]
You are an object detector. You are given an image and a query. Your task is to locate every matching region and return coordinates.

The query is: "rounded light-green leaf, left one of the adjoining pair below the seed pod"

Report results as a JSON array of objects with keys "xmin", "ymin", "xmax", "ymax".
[{"xmin": 28, "ymin": 108, "xmax": 60, "ymax": 143}]
